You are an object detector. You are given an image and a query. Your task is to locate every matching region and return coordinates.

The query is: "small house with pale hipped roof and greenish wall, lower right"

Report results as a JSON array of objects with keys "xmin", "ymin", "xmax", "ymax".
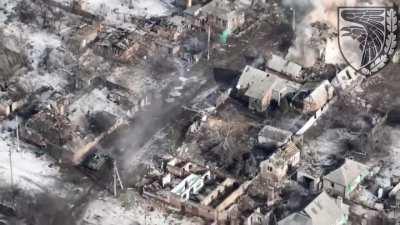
[{"xmin": 323, "ymin": 159, "xmax": 370, "ymax": 199}]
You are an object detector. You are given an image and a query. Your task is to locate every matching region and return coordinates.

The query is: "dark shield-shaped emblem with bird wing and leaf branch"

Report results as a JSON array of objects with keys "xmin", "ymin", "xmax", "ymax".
[{"xmin": 338, "ymin": 7, "xmax": 398, "ymax": 76}]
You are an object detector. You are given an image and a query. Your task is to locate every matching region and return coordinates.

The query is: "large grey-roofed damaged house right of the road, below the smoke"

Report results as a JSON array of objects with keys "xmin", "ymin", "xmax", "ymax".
[{"xmin": 236, "ymin": 66, "xmax": 301, "ymax": 112}]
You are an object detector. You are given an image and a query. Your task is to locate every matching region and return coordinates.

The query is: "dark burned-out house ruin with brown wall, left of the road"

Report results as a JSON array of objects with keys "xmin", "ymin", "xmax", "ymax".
[{"xmin": 21, "ymin": 106, "xmax": 122, "ymax": 165}]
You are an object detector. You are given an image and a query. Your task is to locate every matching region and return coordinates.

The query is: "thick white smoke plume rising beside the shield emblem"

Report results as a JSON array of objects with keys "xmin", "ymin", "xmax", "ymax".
[{"xmin": 283, "ymin": 0, "xmax": 389, "ymax": 67}]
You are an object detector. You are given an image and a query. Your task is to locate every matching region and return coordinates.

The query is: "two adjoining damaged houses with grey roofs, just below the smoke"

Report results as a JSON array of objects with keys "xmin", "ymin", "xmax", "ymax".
[{"xmin": 236, "ymin": 66, "xmax": 334, "ymax": 113}]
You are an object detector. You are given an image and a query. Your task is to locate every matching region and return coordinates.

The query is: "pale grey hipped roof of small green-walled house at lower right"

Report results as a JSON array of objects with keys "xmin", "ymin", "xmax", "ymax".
[{"xmin": 325, "ymin": 159, "xmax": 369, "ymax": 187}]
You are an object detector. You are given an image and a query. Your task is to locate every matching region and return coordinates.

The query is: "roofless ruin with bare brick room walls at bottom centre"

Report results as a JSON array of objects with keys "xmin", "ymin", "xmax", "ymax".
[{"xmin": 143, "ymin": 158, "xmax": 253, "ymax": 224}]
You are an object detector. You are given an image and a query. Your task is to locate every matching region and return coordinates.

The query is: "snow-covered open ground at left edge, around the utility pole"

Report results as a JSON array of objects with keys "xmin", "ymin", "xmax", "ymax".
[{"xmin": 0, "ymin": 122, "xmax": 90, "ymax": 200}]
